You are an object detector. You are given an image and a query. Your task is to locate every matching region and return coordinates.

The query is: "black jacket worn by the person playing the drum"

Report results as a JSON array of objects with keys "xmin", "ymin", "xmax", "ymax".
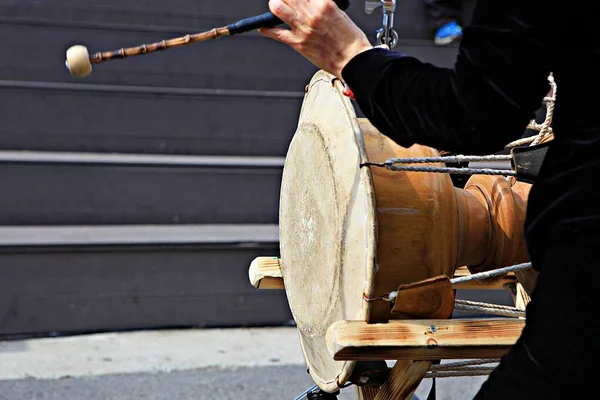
[{"xmin": 342, "ymin": 0, "xmax": 600, "ymax": 267}]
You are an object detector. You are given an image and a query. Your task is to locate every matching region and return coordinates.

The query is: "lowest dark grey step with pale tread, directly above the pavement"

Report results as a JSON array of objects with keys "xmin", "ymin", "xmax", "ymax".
[{"xmin": 0, "ymin": 225, "xmax": 292, "ymax": 335}]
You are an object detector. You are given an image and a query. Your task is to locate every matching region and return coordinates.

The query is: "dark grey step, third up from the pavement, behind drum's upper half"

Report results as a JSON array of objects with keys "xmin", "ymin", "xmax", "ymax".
[{"xmin": 0, "ymin": 81, "xmax": 304, "ymax": 156}]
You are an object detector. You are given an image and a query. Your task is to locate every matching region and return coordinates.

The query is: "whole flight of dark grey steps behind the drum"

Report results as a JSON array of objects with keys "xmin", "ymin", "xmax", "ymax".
[{"xmin": 0, "ymin": 0, "xmax": 468, "ymax": 335}]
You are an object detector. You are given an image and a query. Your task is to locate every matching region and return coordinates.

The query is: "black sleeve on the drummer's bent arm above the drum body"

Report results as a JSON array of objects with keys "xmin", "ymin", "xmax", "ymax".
[{"xmin": 342, "ymin": 0, "xmax": 558, "ymax": 154}]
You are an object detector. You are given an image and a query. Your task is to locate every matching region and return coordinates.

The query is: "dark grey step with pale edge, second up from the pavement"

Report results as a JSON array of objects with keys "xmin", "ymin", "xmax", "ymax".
[{"xmin": 0, "ymin": 152, "xmax": 283, "ymax": 225}]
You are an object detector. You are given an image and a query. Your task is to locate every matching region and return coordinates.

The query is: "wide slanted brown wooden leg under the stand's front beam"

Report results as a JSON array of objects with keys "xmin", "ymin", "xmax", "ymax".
[{"xmin": 375, "ymin": 360, "xmax": 431, "ymax": 400}]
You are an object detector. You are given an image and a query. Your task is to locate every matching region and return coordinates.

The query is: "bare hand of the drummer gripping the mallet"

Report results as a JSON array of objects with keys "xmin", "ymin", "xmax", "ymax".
[{"xmin": 258, "ymin": 0, "xmax": 373, "ymax": 79}]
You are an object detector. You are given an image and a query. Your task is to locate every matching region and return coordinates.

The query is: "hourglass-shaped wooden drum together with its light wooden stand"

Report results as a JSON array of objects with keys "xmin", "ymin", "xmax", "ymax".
[{"xmin": 249, "ymin": 71, "xmax": 548, "ymax": 400}]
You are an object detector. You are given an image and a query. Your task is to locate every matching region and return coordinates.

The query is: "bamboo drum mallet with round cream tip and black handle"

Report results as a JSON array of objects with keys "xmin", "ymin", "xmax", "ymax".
[{"xmin": 65, "ymin": 0, "xmax": 350, "ymax": 78}]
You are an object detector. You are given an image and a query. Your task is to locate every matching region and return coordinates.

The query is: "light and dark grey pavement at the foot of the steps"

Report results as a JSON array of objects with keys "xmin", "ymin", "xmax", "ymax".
[{"xmin": 0, "ymin": 327, "xmax": 485, "ymax": 400}]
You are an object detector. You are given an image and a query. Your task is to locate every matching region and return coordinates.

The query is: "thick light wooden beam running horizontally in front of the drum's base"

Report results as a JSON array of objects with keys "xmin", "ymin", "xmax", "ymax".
[{"xmin": 327, "ymin": 318, "xmax": 525, "ymax": 361}]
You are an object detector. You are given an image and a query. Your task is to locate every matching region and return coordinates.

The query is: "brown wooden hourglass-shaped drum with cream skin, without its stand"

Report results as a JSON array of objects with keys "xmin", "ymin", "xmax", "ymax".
[{"xmin": 279, "ymin": 71, "xmax": 529, "ymax": 392}]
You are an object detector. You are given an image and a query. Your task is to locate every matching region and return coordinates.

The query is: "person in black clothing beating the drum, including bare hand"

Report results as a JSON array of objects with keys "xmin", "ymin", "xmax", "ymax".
[{"xmin": 261, "ymin": 0, "xmax": 600, "ymax": 399}]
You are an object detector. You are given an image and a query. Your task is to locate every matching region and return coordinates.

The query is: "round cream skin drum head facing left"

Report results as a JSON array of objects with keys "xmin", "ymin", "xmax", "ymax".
[{"xmin": 279, "ymin": 71, "xmax": 377, "ymax": 392}]
